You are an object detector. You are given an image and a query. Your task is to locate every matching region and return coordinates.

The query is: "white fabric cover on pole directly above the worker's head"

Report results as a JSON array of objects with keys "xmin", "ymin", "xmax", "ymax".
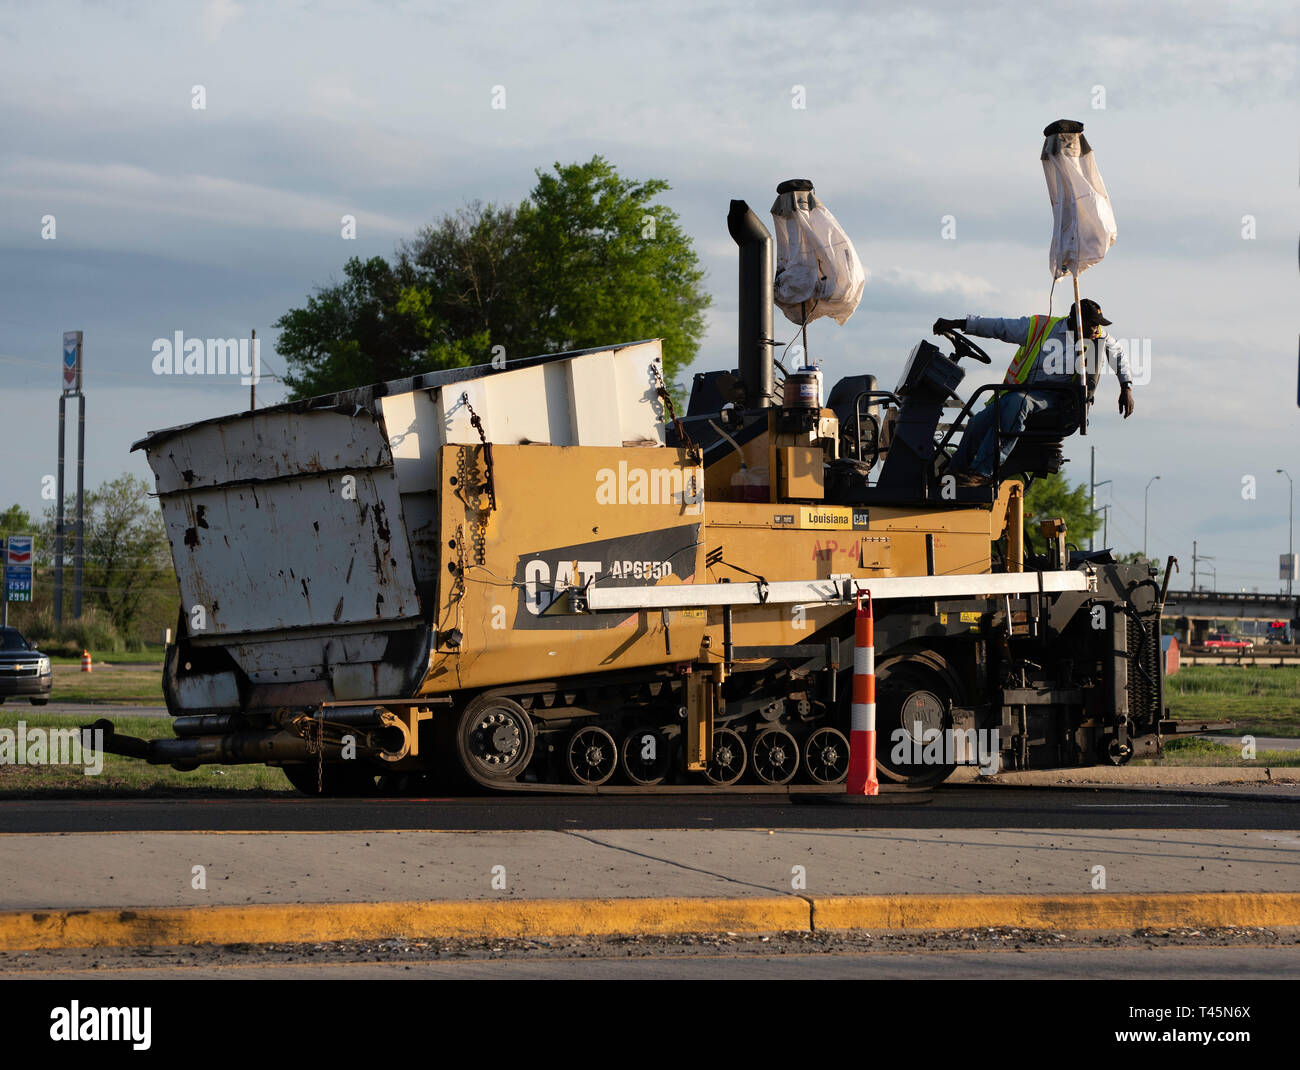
[{"xmin": 1041, "ymin": 120, "xmax": 1117, "ymax": 280}]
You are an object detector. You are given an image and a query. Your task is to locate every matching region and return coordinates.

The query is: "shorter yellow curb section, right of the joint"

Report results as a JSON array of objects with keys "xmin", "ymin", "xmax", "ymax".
[{"xmin": 813, "ymin": 892, "xmax": 1300, "ymax": 930}]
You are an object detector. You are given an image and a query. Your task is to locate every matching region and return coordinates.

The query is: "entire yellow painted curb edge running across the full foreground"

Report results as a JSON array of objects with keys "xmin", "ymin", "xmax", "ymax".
[{"xmin": 0, "ymin": 892, "xmax": 1300, "ymax": 952}]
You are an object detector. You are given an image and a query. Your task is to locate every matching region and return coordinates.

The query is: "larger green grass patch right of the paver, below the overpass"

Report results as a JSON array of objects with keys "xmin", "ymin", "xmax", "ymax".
[{"xmin": 1165, "ymin": 666, "xmax": 1300, "ymax": 738}]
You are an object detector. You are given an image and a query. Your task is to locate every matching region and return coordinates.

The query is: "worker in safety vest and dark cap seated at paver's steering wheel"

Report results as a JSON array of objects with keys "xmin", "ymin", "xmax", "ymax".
[{"xmin": 933, "ymin": 298, "xmax": 1134, "ymax": 486}]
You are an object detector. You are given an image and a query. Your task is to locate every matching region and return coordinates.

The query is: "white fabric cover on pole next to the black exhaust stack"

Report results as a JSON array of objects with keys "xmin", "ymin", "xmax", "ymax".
[{"xmin": 772, "ymin": 178, "xmax": 867, "ymax": 325}]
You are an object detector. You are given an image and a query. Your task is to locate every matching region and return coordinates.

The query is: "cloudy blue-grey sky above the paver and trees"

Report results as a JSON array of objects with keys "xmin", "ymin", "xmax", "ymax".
[{"xmin": 0, "ymin": 0, "xmax": 1300, "ymax": 590}]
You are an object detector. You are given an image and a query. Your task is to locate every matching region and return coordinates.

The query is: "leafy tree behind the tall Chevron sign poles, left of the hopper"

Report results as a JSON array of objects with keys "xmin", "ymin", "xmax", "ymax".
[{"xmin": 40, "ymin": 472, "xmax": 176, "ymax": 634}]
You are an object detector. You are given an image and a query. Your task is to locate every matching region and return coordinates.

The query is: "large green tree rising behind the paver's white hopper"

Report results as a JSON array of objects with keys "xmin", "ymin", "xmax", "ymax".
[{"xmin": 276, "ymin": 156, "xmax": 710, "ymax": 398}]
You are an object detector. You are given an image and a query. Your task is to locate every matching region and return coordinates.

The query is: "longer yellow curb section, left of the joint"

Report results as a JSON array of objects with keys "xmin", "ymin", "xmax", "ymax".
[{"xmin": 0, "ymin": 896, "xmax": 809, "ymax": 950}]
